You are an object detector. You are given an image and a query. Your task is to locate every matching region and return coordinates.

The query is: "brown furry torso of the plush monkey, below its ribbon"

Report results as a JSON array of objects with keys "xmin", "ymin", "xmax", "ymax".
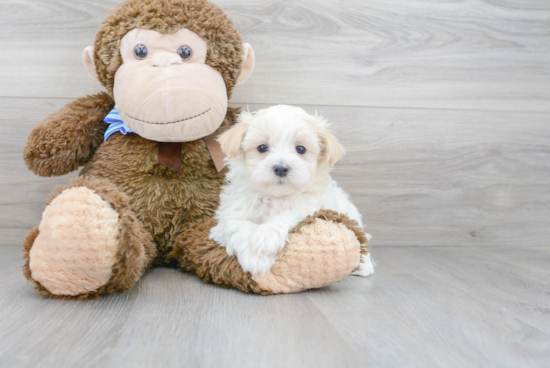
[{"xmin": 81, "ymin": 134, "xmax": 225, "ymax": 263}]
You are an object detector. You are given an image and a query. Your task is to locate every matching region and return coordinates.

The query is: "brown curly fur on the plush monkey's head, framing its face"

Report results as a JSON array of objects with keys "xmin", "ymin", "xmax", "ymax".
[{"xmin": 94, "ymin": 0, "xmax": 243, "ymax": 98}]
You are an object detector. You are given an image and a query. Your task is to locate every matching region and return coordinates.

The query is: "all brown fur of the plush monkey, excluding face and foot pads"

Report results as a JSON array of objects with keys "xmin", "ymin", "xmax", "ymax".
[{"xmin": 23, "ymin": 0, "xmax": 364, "ymax": 300}]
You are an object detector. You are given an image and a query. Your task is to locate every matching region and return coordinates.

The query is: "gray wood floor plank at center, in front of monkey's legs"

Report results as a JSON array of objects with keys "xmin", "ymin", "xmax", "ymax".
[{"xmin": 96, "ymin": 270, "xmax": 359, "ymax": 367}]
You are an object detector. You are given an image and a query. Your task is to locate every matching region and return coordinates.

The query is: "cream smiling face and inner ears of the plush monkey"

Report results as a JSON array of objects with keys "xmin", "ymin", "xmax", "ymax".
[{"xmin": 84, "ymin": 28, "xmax": 254, "ymax": 142}]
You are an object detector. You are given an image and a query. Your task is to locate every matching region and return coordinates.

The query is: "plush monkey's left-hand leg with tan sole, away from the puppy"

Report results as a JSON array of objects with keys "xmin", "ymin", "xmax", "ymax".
[{"xmin": 23, "ymin": 177, "xmax": 156, "ymax": 300}]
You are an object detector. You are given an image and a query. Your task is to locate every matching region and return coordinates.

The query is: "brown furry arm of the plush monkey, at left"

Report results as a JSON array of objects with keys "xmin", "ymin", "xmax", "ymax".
[{"xmin": 23, "ymin": 92, "xmax": 114, "ymax": 176}]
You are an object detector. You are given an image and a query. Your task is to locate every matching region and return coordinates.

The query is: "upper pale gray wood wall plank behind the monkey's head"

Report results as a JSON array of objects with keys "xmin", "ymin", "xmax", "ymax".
[{"xmin": 0, "ymin": 0, "xmax": 550, "ymax": 112}]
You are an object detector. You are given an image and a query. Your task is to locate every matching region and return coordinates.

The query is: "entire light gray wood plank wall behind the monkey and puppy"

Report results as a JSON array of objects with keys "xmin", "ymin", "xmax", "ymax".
[{"xmin": 0, "ymin": 0, "xmax": 550, "ymax": 247}]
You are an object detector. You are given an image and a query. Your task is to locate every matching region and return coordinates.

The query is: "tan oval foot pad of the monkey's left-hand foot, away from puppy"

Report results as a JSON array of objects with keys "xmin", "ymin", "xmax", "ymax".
[{"xmin": 29, "ymin": 187, "xmax": 119, "ymax": 296}]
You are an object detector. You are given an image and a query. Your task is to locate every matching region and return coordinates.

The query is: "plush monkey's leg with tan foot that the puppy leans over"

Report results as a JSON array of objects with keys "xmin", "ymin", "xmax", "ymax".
[{"xmin": 169, "ymin": 210, "xmax": 368, "ymax": 294}]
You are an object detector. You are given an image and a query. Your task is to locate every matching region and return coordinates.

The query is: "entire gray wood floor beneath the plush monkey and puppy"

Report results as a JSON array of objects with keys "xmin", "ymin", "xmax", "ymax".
[{"xmin": 0, "ymin": 246, "xmax": 550, "ymax": 367}]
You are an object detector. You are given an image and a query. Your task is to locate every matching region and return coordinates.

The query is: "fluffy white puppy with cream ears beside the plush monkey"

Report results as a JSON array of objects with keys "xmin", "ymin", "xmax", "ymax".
[{"xmin": 210, "ymin": 105, "xmax": 373, "ymax": 276}]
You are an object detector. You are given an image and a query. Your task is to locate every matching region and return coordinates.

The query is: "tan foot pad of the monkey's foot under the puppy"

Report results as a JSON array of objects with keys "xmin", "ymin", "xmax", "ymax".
[{"xmin": 253, "ymin": 219, "xmax": 361, "ymax": 294}]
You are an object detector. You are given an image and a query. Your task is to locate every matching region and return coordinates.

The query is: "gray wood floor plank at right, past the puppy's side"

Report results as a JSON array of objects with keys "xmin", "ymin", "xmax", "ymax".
[{"xmin": 307, "ymin": 247, "xmax": 550, "ymax": 367}]
